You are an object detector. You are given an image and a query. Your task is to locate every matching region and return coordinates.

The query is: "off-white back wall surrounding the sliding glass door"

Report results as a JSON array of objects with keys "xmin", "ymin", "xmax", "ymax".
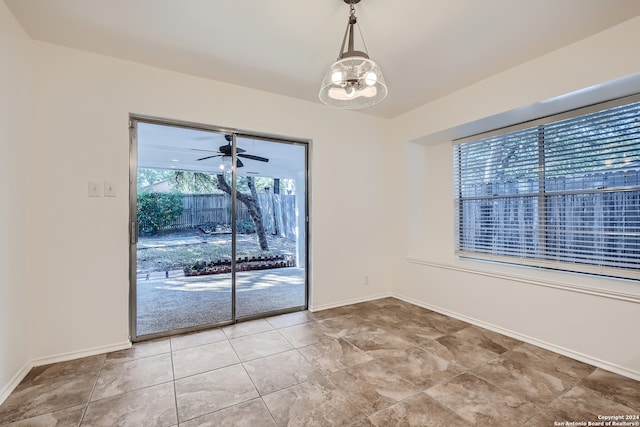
[{"xmin": 25, "ymin": 42, "xmax": 389, "ymax": 359}]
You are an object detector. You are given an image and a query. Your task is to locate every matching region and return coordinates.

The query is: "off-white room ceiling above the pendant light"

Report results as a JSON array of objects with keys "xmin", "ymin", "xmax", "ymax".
[{"xmin": 4, "ymin": 0, "xmax": 640, "ymax": 118}]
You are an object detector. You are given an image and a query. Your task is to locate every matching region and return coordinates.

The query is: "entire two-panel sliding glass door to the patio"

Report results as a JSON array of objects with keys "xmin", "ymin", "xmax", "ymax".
[{"xmin": 130, "ymin": 117, "xmax": 307, "ymax": 340}]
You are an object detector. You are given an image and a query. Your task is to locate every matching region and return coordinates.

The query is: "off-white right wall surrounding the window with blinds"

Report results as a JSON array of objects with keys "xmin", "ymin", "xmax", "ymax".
[{"xmin": 391, "ymin": 18, "xmax": 640, "ymax": 379}]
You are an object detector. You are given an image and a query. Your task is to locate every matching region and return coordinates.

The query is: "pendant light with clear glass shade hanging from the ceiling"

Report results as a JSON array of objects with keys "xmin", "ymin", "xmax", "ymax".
[{"xmin": 319, "ymin": 0, "xmax": 387, "ymax": 109}]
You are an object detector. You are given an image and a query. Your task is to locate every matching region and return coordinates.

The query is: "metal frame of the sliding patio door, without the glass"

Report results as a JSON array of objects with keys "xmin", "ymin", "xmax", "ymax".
[{"xmin": 129, "ymin": 113, "xmax": 311, "ymax": 342}]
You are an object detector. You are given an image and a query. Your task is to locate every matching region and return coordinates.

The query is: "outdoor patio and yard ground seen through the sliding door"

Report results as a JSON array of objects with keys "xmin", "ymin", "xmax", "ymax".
[{"xmin": 136, "ymin": 229, "xmax": 306, "ymax": 336}]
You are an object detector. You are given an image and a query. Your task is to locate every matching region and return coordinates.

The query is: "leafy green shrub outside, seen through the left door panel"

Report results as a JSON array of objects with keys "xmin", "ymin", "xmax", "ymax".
[{"xmin": 138, "ymin": 193, "xmax": 182, "ymax": 234}]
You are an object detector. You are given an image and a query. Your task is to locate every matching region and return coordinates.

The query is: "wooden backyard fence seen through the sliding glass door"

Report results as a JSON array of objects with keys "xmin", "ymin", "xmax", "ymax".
[{"xmin": 163, "ymin": 193, "xmax": 296, "ymax": 240}]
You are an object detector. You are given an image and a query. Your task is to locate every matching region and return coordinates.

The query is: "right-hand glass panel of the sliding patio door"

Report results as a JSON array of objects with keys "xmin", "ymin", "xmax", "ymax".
[{"xmin": 235, "ymin": 136, "xmax": 307, "ymax": 318}]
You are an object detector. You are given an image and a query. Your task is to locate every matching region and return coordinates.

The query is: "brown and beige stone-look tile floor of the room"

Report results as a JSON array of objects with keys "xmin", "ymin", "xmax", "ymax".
[{"xmin": 0, "ymin": 298, "xmax": 640, "ymax": 427}]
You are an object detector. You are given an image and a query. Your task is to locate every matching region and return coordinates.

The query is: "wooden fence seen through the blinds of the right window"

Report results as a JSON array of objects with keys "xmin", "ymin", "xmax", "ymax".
[{"xmin": 458, "ymin": 171, "xmax": 640, "ymax": 268}]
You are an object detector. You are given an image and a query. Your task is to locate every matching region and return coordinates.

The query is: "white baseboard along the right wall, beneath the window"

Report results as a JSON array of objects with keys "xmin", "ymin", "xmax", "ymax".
[{"xmin": 391, "ymin": 293, "xmax": 640, "ymax": 381}]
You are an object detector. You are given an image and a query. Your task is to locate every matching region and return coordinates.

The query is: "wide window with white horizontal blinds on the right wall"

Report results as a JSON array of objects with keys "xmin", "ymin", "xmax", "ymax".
[{"xmin": 454, "ymin": 96, "xmax": 640, "ymax": 279}]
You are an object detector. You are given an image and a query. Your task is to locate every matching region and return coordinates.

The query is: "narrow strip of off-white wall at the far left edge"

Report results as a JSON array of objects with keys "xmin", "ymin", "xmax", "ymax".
[{"xmin": 0, "ymin": 2, "xmax": 31, "ymax": 402}]
